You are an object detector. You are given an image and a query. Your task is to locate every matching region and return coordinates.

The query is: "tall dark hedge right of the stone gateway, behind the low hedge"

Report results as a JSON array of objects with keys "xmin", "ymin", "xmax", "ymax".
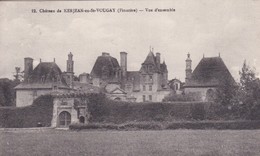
[{"xmin": 88, "ymin": 94, "xmax": 209, "ymax": 124}]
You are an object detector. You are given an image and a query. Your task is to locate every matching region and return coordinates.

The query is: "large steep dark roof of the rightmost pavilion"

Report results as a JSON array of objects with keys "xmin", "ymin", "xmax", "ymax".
[{"xmin": 184, "ymin": 57, "xmax": 235, "ymax": 87}]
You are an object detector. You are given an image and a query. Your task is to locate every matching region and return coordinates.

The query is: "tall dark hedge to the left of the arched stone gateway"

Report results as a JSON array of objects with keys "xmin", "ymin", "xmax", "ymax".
[{"xmin": 0, "ymin": 95, "xmax": 53, "ymax": 128}]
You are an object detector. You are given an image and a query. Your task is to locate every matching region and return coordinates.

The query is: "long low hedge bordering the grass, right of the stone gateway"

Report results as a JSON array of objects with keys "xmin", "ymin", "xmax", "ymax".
[{"xmin": 69, "ymin": 120, "xmax": 260, "ymax": 130}]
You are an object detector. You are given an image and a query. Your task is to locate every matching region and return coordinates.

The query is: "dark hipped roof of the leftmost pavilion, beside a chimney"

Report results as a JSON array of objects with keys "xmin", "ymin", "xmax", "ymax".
[{"xmin": 15, "ymin": 62, "xmax": 69, "ymax": 89}]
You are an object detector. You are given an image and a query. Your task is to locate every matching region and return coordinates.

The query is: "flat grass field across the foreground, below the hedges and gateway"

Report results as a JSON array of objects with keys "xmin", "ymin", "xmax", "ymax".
[{"xmin": 0, "ymin": 129, "xmax": 260, "ymax": 156}]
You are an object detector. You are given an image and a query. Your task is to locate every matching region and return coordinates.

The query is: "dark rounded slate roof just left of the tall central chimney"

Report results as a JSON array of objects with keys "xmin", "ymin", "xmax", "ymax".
[{"xmin": 91, "ymin": 55, "xmax": 120, "ymax": 79}]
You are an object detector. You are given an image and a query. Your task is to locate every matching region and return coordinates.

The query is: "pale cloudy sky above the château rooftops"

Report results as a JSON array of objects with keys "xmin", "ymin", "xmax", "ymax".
[{"xmin": 0, "ymin": 0, "xmax": 260, "ymax": 81}]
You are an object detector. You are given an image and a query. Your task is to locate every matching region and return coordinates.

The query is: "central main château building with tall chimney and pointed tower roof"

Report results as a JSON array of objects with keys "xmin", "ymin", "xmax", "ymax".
[{"xmin": 90, "ymin": 50, "xmax": 170, "ymax": 102}]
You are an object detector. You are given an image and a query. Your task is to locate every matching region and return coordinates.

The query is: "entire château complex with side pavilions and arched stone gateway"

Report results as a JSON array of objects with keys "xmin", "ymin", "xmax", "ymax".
[{"xmin": 12, "ymin": 50, "xmax": 235, "ymax": 127}]
